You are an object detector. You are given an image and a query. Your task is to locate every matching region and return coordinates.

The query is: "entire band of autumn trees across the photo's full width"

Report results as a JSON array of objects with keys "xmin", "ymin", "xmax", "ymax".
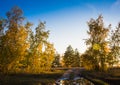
[{"xmin": 0, "ymin": 6, "xmax": 120, "ymax": 74}]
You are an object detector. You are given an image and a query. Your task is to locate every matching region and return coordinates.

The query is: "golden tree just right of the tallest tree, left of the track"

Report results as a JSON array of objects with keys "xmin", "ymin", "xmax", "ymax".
[{"xmin": 28, "ymin": 22, "xmax": 54, "ymax": 72}]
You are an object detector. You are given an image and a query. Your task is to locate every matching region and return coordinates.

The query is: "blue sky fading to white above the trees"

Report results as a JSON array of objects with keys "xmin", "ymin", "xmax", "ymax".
[{"xmin": 0, "ymin": 0, "xmax": 120, "ymax": 54}]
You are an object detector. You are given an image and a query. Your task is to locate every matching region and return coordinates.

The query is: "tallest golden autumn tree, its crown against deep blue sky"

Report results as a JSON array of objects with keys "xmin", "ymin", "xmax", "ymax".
[{"xmin": 2, "ymin": 7, "xmax": 27, "ymax": 71}]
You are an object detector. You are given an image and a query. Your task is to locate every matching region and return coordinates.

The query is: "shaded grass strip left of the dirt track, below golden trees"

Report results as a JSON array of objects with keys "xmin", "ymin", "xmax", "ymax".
[{"xmin": 0, "ymin": 70, "xmax": 65, "ymax": 85}]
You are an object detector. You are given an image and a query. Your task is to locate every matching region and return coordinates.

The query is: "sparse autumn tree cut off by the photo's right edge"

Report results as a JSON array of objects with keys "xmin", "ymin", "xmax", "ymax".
[{"xmin": 108, "ymin": 23, "xmax": 120, "ymax": 66}]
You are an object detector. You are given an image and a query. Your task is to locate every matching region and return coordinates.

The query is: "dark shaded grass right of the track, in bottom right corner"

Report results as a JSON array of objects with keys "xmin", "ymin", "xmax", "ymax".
[{"xmin": 82, "ymin": 68, "xmax": 120, "ymax": 85}]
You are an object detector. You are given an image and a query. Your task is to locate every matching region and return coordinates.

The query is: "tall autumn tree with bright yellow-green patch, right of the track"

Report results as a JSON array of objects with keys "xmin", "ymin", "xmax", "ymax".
[{"xmin": 86, "ymin": 15, "xmax": 110, "ymax": 70}]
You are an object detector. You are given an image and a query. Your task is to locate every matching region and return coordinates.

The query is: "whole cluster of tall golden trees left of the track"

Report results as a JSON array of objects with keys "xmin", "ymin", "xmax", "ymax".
[{"xmin": 0, "ymin": 7, "xmax": 55, "ymax": 73}]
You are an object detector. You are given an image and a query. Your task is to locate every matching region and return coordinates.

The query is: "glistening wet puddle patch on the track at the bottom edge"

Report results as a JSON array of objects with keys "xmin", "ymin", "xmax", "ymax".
[{"xmin": 55, "ymin": 77, "xmax": 94, "ymax": 85}]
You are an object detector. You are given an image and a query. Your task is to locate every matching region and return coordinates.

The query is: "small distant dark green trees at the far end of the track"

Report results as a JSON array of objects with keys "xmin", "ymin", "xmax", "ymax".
[{"xmin": 52, "ymin": 45, "xmax": 80, "ymax": 67}]
